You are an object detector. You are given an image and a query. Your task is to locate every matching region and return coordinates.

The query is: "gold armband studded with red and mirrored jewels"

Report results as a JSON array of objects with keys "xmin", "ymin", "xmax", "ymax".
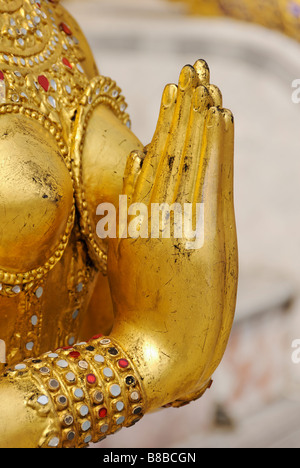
[{"xmin": 5, "ymin": 337, "xmax": 145, "ymax": 448}]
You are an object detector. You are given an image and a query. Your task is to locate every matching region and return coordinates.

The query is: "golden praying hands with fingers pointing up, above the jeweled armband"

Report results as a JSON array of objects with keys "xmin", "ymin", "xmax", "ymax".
[{"xmin": 108, "ymin": 62, "xmax": 237, "ymax": 408}]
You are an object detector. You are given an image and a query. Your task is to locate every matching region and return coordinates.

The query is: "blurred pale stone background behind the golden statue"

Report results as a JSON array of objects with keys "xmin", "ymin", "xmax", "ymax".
[{"xmin": 64, "ymin": 0, "xmax": 300, "ymax": 448}]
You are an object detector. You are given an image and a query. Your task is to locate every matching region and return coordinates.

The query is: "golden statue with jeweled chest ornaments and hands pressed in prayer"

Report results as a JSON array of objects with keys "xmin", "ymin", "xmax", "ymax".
[{"xmin": 0, "ymin": 0, "xmax": 240, "ymax": 448}]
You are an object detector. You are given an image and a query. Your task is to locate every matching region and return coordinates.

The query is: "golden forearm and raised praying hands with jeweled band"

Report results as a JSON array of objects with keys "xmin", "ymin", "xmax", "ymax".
[{"xmin": 0, "ymin": 61, "xmax": 238, "ymax": 447}]
